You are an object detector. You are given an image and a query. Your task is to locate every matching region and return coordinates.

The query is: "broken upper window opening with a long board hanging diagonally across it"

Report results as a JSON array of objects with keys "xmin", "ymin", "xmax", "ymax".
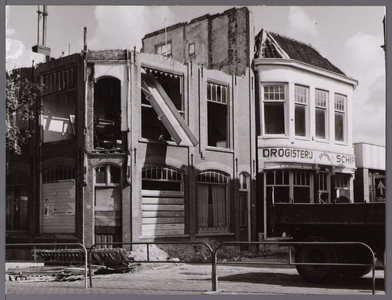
[{"xmin": 141, "ymin": 68, "xmax": 197, "ymax": 146}]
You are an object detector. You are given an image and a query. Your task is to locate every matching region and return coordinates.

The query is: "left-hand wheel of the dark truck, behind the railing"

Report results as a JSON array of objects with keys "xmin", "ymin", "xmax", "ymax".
[{"xmin": 295, "ymin": 237, "xmax": 340, "ymax": 283}]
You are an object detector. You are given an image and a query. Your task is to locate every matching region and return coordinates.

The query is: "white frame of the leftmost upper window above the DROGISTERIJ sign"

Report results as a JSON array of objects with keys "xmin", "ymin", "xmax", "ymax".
[{"xmin": 260, "ymin": 82, "xmax": 289, "ymax": 138}]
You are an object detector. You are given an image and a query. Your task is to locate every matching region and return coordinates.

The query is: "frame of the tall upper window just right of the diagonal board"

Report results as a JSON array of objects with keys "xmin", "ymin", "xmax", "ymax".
[{"xmin": 206, "ymin": 79, "xmax": 231, "ymax": 149}]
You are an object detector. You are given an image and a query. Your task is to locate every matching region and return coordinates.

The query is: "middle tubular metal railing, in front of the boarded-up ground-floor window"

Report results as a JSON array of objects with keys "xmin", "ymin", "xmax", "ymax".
[{"xmin": 88, "ymin": 242, "xmax": 214, "ymax": 287}]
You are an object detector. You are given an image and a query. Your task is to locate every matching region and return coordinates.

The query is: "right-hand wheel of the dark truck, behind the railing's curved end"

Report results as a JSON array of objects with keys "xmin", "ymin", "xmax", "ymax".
[{"xmin": 341, "ymin": 245, "xmax": 373, "ymax": 278}]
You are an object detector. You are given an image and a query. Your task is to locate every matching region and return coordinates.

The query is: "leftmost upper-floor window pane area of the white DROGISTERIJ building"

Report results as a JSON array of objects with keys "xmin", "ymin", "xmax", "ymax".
[{"xmin": 264, "ymin": 85, "xmax": 285, "ymax": 134}]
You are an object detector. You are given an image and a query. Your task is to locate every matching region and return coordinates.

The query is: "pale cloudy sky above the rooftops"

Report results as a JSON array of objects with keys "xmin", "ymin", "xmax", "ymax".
[{"xmin": 6, "ymin": 5, "xmax": 386, "ymax": 146}]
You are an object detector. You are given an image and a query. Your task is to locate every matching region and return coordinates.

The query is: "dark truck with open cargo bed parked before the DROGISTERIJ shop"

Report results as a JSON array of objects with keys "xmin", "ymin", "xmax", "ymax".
[{"xmin": 268, "ymin": 202, "xmax": 385, "ymax": 283}]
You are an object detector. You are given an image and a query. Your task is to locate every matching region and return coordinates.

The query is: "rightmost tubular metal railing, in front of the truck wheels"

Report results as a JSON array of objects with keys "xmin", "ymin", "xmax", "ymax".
[{"xmin": 211, "ymin": 241, "xmax": 377, "ymax": 295}]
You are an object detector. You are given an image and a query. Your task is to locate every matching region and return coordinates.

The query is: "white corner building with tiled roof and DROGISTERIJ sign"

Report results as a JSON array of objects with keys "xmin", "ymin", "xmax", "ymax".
[{"xmin": 254, "ymin": 30, "xmax": 358, "ymax": 236}]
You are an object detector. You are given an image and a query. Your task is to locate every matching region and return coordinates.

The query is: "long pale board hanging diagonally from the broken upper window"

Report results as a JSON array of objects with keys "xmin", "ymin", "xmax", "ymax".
[{"xmin": 142, "ymin": 73, "xmax": 198, "ymax": 146}]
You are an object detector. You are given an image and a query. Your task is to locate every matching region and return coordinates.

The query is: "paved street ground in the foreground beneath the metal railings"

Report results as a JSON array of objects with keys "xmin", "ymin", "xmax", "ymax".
[{"xmin": 6, "ymin": 264, "xmax": 385, "ymax": 295}]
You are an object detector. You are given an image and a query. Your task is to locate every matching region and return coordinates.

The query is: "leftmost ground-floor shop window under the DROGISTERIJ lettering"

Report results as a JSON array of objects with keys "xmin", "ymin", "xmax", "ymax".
[{"xmin": 266, "ymin": 170, "xmax": 290, "ymax": 205}]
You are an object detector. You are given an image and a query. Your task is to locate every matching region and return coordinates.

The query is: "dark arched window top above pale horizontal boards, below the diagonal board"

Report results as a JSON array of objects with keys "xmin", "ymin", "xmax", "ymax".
[{"xmin": 142, "ymin": 167, "xmax": 183, "ymax": 191}]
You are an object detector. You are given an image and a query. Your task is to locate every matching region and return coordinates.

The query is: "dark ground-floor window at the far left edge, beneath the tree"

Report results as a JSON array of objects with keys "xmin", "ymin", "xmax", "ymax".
[{"xmin": 5, "ymin": 172, "xmax": 29, "ymax": 230}]
